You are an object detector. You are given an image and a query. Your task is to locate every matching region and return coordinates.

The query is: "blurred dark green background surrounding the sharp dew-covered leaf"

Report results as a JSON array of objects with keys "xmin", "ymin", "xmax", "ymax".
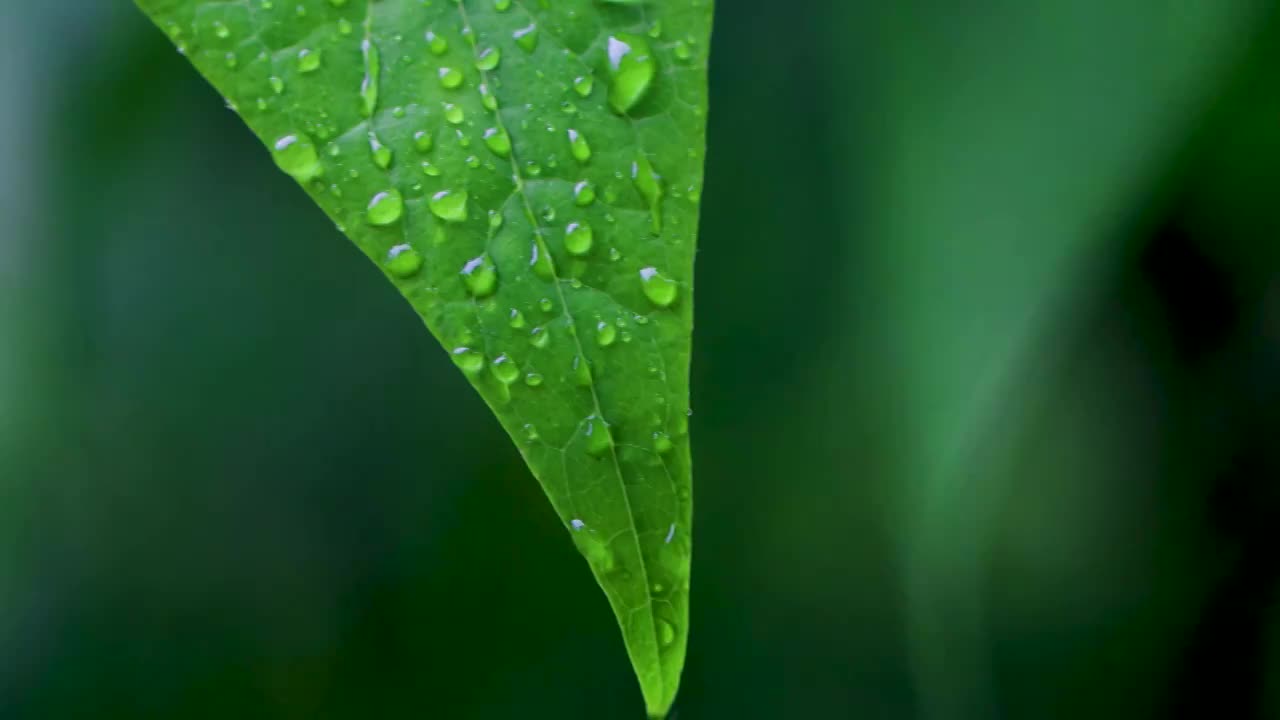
[{"xmin": 0, "ymin": 0, "xmax": 1280, "ymax": 720}]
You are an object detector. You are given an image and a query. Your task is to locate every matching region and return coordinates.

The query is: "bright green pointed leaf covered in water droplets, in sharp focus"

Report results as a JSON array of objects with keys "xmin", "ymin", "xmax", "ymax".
[{"xmin": 129, "ymin": 0, "xmax": 712, "ymax": 716}]
